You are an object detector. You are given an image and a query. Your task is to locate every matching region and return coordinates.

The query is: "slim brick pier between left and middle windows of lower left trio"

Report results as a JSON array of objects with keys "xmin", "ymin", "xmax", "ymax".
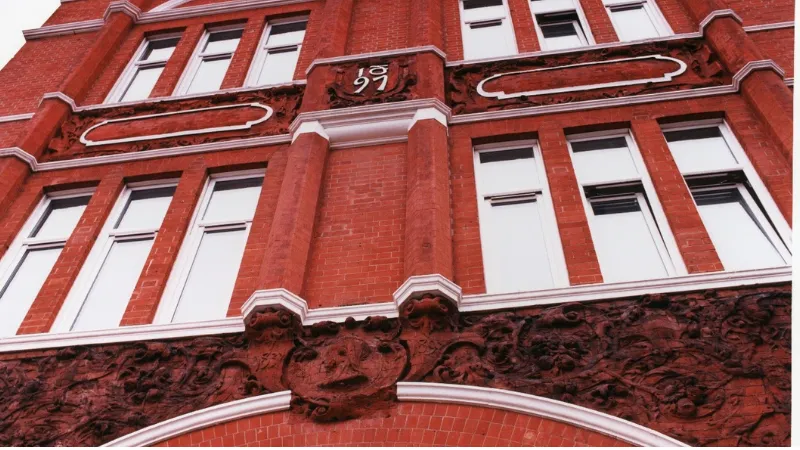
[{"xmin": 17, "ymin": 169, "xmax": 123, "ymax": 334}]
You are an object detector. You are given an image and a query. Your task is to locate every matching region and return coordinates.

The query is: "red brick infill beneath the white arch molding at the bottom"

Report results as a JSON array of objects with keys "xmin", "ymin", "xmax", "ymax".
[{"xmin": 156, "ymin": 403, "xmax": 630, "ymax": 447}]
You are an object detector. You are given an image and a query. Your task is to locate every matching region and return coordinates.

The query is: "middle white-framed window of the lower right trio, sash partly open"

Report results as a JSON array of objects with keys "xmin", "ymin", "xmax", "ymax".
[{"xmin": 568, "ymin": 130, "xmax": 687, "ymax": 283}]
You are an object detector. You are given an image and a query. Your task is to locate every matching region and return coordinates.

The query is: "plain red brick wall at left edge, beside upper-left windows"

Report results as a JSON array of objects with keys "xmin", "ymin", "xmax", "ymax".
[{"xmin": 0, "ymin": 33, "xmax": 97, "ymax": 116}]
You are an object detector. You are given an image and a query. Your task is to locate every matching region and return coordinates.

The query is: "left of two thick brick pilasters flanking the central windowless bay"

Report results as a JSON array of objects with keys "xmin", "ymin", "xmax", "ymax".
[{"xmin": 259, "ymin": 133, "xmax": 328, "ymax": 294}]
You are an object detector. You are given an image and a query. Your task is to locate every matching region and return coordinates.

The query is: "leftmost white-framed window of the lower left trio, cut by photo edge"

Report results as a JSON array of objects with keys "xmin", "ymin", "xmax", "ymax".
[{"xmin": 0, "ymin": 189, "xmax": 92, "ymax": 337}]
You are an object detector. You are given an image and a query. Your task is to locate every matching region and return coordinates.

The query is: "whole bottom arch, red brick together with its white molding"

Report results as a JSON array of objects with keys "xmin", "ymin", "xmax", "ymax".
[{"xmin": 104, "ymin": 382, "xmax": 686, "ymax": 447}]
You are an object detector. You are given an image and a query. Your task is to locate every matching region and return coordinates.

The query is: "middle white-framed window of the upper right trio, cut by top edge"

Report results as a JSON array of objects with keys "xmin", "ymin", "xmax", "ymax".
[{"xmin": 529, "ymin": 0, "xmax": 595, "ymax": 51}]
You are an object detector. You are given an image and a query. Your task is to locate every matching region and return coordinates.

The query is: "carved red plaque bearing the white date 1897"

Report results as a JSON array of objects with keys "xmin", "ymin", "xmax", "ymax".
[{"xmin": 327, "ymin": 56, "xmax": 417, "ymax": 108}]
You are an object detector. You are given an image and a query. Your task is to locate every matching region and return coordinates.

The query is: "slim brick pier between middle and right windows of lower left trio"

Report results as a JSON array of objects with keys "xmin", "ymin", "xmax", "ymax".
[{"xmin": 120, "ymin": 157, "xmax": 206, "ymax": 326}]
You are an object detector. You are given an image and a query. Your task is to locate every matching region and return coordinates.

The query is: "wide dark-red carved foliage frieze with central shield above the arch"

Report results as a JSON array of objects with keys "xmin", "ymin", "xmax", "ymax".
[{"xmin": 0, "ymin": 285, "xmax": 791, "ymax": 446}]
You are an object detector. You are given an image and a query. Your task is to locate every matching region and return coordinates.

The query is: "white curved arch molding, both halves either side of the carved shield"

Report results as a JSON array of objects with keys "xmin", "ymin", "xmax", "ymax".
[{"xmin": 103, "ymin": 382, "xmax": 687, "ymax": 447}]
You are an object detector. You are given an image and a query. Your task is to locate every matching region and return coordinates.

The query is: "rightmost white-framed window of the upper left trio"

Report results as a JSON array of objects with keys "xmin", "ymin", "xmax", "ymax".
[{"xmin": 245, "ymin": 17, "xmax": 308, "ymax": 87}]
